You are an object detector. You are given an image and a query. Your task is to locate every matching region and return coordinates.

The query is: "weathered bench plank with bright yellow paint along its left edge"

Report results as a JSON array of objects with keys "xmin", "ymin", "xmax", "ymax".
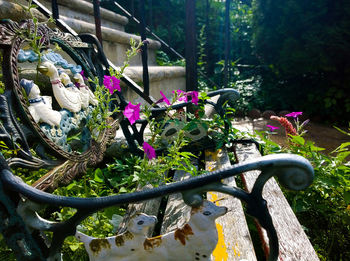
[{"xmin": 205, "ymin": 147, "xmax": 257, "ymax": 261}]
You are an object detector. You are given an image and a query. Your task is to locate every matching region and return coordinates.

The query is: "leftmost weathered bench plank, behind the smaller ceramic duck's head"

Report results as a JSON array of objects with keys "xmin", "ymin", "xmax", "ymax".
[{"xmin": 117, "ymin": 185, "xmax": 162, "ymax": 237}]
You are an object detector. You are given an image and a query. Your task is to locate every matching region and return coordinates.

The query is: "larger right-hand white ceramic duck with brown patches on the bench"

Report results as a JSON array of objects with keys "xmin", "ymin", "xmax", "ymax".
[{"xmin": 139, "ymin": 200, "xmax": 227, "ymax": 261}]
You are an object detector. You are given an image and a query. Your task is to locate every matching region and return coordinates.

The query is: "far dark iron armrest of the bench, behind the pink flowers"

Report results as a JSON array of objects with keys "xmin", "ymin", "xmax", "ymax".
[{"xmin": 120, "ymin": 88, "xmax": 239, "ymax": 155}]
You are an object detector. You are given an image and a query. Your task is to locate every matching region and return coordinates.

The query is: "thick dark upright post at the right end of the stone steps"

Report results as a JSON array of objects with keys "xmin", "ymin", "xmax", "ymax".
[{"xmin": 185, "ymin": 0, "xmax": 198, "ymax": 91}]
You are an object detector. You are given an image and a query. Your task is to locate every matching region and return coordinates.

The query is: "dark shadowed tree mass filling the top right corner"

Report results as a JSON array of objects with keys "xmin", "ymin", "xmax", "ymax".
[{"xmin": 253, "ymin": 0, "xmax": 350, "ymax": 123}]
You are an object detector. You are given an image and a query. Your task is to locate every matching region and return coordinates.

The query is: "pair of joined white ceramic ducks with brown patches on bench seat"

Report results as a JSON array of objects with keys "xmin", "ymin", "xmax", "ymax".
[{"xmin": 75, "ymin": 200, "xmax": 227, "ymax": 261}]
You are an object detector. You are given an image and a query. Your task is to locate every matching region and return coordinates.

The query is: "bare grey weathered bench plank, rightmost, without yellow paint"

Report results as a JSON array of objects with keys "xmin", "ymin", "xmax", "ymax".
[{"xmin": 236, "ymin": 123, "xmax": 319, "ymax": 261}]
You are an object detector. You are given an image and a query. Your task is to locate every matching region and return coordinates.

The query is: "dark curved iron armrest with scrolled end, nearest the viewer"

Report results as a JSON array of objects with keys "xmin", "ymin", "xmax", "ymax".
[{"xmin": 0, "ymin": 154, "xmax": 314, "ymax": 260}]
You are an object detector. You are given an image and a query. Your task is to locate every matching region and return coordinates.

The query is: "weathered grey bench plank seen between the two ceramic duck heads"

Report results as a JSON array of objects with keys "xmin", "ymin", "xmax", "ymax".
[{"xmin": 160, "ymin": 170, "xmax": 191, "ymax": 234}]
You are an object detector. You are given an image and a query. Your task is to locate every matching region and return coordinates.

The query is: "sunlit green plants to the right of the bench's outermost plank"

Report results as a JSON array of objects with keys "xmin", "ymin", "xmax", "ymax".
[{"xmin": 258, "ymin": 123, "xmax": 350, "ymax": 261}]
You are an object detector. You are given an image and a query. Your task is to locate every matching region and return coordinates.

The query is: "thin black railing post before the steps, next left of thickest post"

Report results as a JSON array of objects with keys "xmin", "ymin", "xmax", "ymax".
[{"xmin": 139, "ymin": 0, "xmax": 149, "ymax": 95}]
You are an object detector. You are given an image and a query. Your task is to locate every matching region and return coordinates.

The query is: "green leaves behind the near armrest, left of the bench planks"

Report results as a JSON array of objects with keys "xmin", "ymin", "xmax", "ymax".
[{"xmin": 52, "ymin": 157, "xmax": 138, "ymax": 261}]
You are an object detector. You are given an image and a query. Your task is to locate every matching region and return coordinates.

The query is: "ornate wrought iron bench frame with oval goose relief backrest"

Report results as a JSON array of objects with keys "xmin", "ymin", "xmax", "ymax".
[{"xmin": 0, "ymin": 18, "xmax": 313, "ymax": 260}]
